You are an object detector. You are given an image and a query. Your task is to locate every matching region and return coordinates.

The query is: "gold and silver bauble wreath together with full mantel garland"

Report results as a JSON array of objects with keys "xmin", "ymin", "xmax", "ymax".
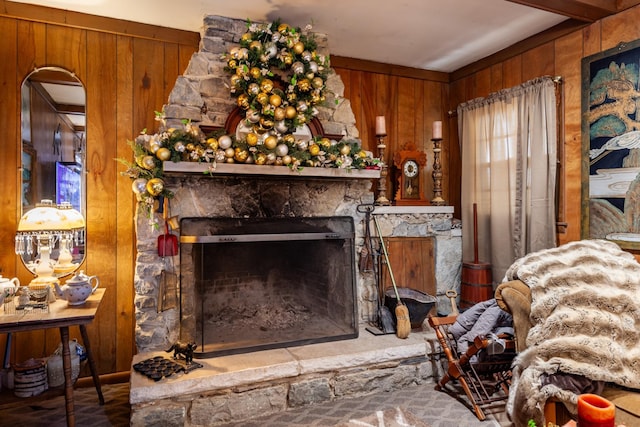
[{"xmin": 117, "ymin": 21, "xmax": 379, "ymax": 222}]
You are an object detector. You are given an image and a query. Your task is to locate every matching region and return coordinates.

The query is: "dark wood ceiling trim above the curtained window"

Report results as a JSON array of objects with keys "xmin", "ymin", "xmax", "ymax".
[{"xmin": 451, "ymin": 19, "xmax": 589, "ymax": 82}]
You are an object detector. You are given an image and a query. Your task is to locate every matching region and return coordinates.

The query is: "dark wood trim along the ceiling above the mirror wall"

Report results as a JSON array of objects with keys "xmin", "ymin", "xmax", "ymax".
[{"xmin": 0, "ymin": 0, "xmax": 200, "ymax": 46}]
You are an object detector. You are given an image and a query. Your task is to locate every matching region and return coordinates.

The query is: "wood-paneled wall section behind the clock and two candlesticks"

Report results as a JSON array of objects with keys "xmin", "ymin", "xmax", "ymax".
[{"xmin": 331, "ymin": 57, "xmax": 455, "ymax": 209}]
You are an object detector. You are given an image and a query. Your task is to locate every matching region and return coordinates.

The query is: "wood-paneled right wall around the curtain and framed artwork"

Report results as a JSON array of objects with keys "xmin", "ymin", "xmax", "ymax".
[{"xmin": 448, "ymin": 6, "xmax": 640, "ymax": 244}]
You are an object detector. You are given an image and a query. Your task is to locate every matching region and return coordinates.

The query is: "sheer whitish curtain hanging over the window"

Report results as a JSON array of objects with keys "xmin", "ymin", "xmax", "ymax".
[{"xmin": 458, "ymin": 77, "xmax": 557, "ymax": 283}]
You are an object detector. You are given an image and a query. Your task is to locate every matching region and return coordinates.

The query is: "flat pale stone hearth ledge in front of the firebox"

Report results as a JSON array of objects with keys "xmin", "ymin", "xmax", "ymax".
[{"xmin": 129, "ymin": 328, "xmax": 434, "ymax": 405}]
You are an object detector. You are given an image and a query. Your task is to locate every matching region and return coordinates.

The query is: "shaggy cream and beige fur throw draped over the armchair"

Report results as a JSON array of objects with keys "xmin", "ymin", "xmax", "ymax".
[{"xmin": 504, "ymin": 240, "xmax": 640, "ymax": 426}]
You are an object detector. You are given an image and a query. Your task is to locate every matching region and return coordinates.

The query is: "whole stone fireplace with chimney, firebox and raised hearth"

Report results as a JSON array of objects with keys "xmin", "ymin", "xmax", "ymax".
[{"xmin": 130, "ymin": 16, "xmax": 462, "ymax": 426}]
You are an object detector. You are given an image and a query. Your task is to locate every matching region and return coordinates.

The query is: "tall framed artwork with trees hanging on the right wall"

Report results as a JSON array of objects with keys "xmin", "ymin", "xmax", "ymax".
[{"xmin": 581, "ymin": 40, "xmax": 640, "ymax": 250}]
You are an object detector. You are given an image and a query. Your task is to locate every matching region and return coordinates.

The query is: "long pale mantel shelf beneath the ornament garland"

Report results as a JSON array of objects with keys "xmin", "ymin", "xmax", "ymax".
[{"xmin": 163, "ymin": 161, "xmax": 380, "ymax": 179}]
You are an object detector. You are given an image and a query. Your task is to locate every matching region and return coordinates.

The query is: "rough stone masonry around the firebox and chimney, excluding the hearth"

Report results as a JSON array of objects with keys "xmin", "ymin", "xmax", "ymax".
[{"xmin": 135, "ymin": 16, "xmax": 462, "ymax": 352}]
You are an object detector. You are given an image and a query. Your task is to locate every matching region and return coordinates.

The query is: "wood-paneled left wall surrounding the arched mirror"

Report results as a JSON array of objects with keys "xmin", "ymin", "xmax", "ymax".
[{"xmin": 0, "ymin": 2, "xmax": 199, "ymax": 374}]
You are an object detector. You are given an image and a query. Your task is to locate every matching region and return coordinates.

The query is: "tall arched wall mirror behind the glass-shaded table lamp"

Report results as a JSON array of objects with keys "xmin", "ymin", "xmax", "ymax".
[{"xmin": 16, "ymin": 67, "xmax": 86, "ymax": 277}]
